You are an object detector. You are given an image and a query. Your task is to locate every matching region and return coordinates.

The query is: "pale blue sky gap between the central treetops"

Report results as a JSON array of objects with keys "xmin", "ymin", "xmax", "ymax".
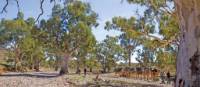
[{"xmin": 84, "ymin": 0, "xmax": 142, "ymax": 41}]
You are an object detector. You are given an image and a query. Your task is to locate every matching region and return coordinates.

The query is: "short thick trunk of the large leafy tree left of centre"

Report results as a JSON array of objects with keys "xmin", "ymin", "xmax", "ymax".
[{"xmin": 60, "ymin": 54, "xmax": 70, "ymax": 75}]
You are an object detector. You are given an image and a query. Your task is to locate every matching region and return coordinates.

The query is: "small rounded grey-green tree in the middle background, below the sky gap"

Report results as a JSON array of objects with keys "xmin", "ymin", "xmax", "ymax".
[{"xmin": 97, "ymin": 36, "xmax": 123, "ymax": 72}]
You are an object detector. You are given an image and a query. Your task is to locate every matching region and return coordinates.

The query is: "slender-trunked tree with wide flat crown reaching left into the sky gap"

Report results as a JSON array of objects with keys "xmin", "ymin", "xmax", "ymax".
[{"xmin": 106, "ymin": 17, "xmax": 157, "ymax": 66}]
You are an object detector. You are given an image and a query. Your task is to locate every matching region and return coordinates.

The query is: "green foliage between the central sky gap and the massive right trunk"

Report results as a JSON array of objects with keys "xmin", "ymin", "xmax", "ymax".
[{"xmin": 105, "ymin": 0, "xmax": 179, "ymax": 68}]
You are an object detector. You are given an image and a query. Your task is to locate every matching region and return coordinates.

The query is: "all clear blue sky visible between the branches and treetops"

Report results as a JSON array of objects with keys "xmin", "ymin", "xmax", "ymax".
[{"xmin": 0, "ymin": 0, "xmax": 143, "ymax": 62}]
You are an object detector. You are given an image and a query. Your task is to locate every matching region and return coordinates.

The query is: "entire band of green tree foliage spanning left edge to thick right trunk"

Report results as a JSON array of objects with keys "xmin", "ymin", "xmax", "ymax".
[{"xmin": 0, "ymin": 0, "xmax": 179, "ymax": 71}]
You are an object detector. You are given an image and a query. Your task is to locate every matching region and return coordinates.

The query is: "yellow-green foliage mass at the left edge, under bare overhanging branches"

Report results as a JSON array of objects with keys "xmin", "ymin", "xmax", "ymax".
[{"xmin": 0, "ymin": 12, "xmax": 44, "ymax": 71}]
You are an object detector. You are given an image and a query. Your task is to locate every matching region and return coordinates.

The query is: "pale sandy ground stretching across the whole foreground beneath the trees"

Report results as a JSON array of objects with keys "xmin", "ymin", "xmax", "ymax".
[{"xmin": 0, "ymin": 72, "xmax": 172, "ymax": 87}]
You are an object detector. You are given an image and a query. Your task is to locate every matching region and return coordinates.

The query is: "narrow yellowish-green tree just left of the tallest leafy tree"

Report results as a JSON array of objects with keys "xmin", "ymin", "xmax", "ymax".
[{"xmin": 20, "ymin": 18, "xmax": 45, "ymax": 71}]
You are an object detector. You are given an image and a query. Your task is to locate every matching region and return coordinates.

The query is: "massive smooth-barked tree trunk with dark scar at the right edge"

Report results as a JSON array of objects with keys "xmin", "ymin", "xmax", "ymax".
[{"xmin": 175, "ymin": 0, "xmax": 200, "ymax": 87}]
